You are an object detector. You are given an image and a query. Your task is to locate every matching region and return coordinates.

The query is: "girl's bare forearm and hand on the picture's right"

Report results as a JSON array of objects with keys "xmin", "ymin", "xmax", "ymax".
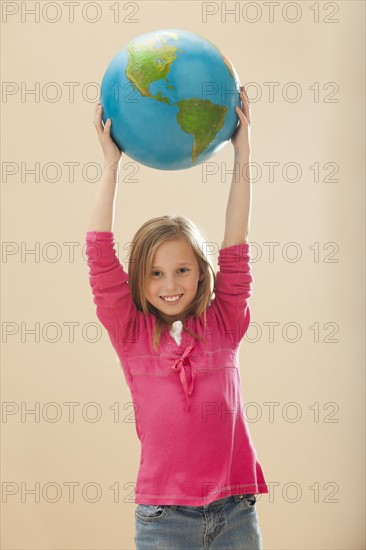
[{"xmin": 224, "ymin": 86, "xmax": 252, "ymax": 247}]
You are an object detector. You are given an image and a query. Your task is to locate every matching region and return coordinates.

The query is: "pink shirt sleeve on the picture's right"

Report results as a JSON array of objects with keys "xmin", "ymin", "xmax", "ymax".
[{"xmin": 210, "ymin": 243, "xmax": 254, "ymax": 345}]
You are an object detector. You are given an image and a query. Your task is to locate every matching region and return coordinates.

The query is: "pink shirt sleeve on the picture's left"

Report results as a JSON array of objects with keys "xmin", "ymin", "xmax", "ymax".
[{"xmin": 86, "ymin": 231, "xmax": 137, "ymax": 349}]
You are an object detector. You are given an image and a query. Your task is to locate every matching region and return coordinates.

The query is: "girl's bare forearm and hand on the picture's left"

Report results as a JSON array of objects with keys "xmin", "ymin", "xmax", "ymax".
[{"xmin": 87, "ymin": 103, "xmax": 121, "ymax": 231}]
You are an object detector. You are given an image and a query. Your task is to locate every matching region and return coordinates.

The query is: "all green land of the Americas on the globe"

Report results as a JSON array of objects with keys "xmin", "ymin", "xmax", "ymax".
[{"xmin": 126, "ymin": 36, "xmax": 231, "ymax": 162}]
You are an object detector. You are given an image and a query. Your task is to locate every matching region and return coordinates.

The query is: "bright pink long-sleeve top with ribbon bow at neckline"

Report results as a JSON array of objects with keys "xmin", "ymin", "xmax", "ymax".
[{"xmin": 86, "ymin": 231, "xmax": 268, "ymax": 506}]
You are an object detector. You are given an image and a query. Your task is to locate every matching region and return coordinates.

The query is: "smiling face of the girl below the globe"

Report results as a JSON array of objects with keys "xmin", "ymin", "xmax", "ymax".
[{"xmin": 146, "ymin": 239, "xmax": 204, "ymax": 324}]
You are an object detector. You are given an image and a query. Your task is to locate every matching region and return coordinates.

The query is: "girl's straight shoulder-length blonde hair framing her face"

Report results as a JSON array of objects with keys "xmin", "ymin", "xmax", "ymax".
[{"xmin": 128, "ymin": 214, "xmax": 216, "ymax": 352}]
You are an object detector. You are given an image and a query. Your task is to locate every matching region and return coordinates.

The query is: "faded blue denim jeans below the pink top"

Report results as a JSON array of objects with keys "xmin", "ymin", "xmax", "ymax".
[{"xmin": 135, "ymin": 494, "xmax": 262, "ymax": 550}]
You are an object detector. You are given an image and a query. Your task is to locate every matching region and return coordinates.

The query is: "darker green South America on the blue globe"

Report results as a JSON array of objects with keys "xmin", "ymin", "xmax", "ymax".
[{"xmin": 175, "ymin": 97, "xmax": 227, "ymax": 161}]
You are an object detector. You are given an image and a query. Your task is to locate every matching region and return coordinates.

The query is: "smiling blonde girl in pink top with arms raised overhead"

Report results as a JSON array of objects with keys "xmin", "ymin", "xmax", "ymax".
[{"xmin": 86, "ymin": 86, "xmax": 268, "ymax": 550}]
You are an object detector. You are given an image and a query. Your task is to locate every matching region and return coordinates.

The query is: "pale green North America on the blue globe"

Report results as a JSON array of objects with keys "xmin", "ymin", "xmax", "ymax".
[{"xmin": 126, "ymin": 40, "xmax": 182, "ymax": 105}]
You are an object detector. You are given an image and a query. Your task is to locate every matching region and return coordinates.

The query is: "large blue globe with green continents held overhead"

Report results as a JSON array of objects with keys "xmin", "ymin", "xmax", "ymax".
[{"xmin": 100, "ymin": 29, "xmax": 240, "ymax": 170}]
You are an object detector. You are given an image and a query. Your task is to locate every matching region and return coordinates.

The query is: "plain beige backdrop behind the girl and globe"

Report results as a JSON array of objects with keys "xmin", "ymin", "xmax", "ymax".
[{"xmin": 1, "ymin": 1, "xmax": 365, "ymax": 550}]
